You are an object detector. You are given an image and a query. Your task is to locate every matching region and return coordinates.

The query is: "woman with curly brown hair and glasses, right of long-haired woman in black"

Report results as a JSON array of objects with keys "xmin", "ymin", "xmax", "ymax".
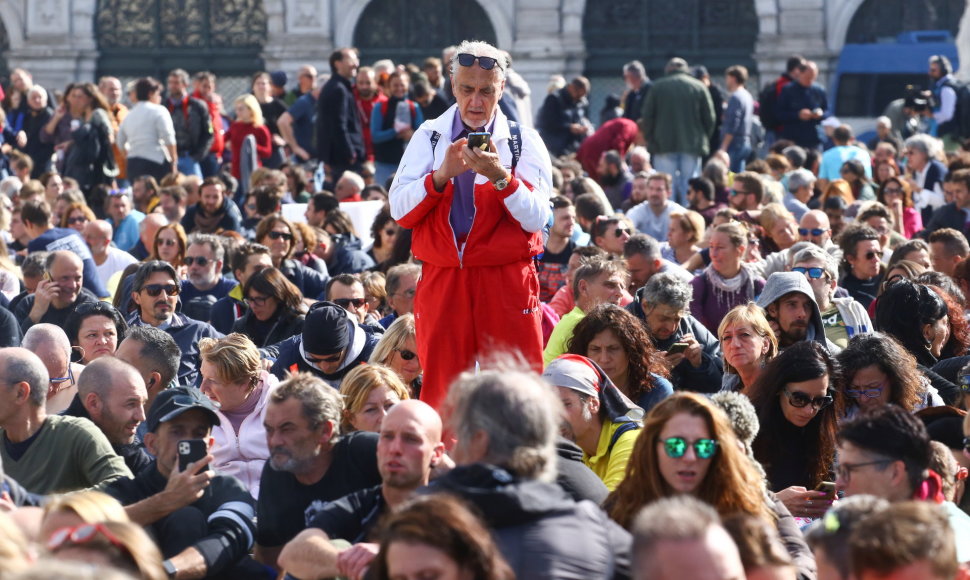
[{"xmin": 836, "ymin": 332, "xmax": 943, "ymax": 416}]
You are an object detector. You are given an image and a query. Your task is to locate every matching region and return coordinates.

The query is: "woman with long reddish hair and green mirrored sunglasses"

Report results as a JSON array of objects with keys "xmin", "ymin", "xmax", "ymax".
[{"xmin": 603, "ymin": 392, "xmax": 815, "ymax": 578}]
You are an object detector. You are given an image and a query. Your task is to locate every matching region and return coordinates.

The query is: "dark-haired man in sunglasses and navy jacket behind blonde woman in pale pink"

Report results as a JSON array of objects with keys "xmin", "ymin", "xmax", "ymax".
[{"xmin": 128, "ymin": 260, "xmax": 223, "ymax": 385}]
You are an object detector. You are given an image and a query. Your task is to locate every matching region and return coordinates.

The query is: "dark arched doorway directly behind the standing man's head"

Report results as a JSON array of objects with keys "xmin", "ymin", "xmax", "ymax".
[{"xmin": 354, "ymin": 0, "xmax": 496, "ymax": 66}]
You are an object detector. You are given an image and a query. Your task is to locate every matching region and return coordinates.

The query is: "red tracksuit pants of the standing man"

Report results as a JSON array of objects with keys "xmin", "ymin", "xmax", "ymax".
[{"xmin": 414, "ymin": 260, "xmax": 542, "ymax": 409}]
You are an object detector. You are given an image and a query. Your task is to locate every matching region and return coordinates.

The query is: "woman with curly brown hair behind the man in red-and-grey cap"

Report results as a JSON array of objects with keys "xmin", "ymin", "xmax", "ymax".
[{"xmin": 569, "ymin": 304, "xmax": 674, "ymax": 412}]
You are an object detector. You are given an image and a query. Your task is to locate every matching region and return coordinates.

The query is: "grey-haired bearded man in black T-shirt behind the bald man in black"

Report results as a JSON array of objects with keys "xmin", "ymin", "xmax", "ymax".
[{"xmin": 255, "ymin": 373, "xmax": 381, "ymax": 566}]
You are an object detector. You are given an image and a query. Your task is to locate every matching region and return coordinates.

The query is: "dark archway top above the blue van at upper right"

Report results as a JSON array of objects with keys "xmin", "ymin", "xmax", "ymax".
[{"xmin": 845, "ymin": 0, "xmax": 967, "ymax": 44}]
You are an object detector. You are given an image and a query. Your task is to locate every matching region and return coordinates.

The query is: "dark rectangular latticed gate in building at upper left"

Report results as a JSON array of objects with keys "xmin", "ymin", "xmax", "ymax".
[{"xmin": 95, "ymin": 0, "xmax": 266, "ymax": 96}]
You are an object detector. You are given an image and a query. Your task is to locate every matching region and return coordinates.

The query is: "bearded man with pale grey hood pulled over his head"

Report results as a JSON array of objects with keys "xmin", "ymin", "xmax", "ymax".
[{"xmin": 757, "ymin": 272, "xmax": 842, "ymax": 355}]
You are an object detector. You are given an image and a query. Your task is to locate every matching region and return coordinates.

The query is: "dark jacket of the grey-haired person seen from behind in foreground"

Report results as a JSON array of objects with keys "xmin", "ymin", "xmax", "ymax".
[{"xmin": 423, "ymin": 464, "xmax": 632, "ymax": 580}]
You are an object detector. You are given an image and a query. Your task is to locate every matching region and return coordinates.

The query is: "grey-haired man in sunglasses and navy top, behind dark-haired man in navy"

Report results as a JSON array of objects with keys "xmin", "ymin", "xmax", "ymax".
[{"xmin": 182, "ymin": 234, "xmax": 236, "ymax": 322}]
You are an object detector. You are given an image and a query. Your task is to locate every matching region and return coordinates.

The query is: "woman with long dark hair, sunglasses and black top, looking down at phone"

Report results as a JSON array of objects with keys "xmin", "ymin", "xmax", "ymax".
[{"xmin": 748, "ymin": 341, "xmax": 843, "ymax": 517}]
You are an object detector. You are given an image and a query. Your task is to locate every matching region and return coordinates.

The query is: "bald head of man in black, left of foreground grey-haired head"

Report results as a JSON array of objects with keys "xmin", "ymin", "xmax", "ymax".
[{"xmin": 377, "ymin": 400, "xmax": 445, "ymax": 495}]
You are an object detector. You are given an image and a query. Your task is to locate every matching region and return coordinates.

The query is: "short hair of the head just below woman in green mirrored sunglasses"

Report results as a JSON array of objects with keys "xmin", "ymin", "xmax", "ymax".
[{"xmin": 633, "ymin": 495, "xmax": 721, "ymax": 577}]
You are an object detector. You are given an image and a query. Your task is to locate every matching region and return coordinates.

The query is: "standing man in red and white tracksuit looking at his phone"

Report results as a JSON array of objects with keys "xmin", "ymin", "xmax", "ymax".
[{"xmin": 390, "ymin": 41, "xmax": 552, "ymax": 408}]
